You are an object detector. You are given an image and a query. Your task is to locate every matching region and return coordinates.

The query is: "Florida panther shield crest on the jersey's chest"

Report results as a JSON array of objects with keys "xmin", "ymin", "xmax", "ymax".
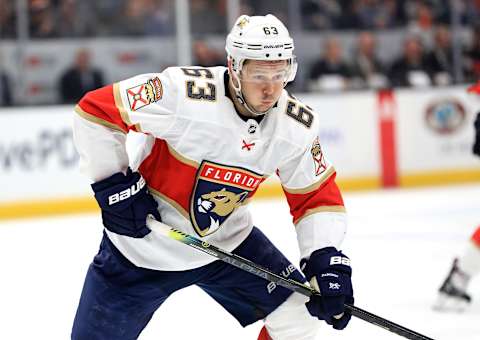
[{"xmin": 190, "ymin": 161, "xmax": 264, "ymax": 237}]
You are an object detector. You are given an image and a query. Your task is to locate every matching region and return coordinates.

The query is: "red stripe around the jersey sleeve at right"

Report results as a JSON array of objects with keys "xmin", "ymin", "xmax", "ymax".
[{"xmin": 284, "ymin": 173, "xmax": 345, "ymax": 224}]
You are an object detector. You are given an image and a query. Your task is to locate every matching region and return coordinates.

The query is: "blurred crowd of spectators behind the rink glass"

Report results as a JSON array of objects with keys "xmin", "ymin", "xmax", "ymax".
[{"xmin": 0, "ymin": 0, "xmax": 480, "ymax": 106}]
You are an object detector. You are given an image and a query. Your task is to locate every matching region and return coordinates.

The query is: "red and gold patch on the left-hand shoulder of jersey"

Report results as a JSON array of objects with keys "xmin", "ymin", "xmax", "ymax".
[{"xmin": 126, "ymin": 77, "xmax": 163, "ymax": 111}]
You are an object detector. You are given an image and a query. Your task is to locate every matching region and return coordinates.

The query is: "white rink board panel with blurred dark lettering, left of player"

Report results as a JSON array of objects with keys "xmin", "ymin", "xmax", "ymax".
[{"xmin": 0, "ymin": 107, "xmax": 89, "ymax": 203}]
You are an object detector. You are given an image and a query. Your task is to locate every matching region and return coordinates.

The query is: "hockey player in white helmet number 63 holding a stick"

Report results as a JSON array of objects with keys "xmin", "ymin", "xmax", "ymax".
[{"xmin": 72, "ymin": 15, "xmax": 353, "ymax": 340}]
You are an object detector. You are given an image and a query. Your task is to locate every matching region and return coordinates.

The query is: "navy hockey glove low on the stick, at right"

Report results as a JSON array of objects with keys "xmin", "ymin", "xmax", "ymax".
[{"xmin": 301, "ymin": 247, "xmax": 353, "ymax": 330}]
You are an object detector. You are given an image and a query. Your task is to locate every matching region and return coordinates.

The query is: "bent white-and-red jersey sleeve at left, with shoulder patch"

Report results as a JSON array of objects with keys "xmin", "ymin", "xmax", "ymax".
[{"xmin": 73, "ymin": 69, "xmax": 177, "ymax": 181}]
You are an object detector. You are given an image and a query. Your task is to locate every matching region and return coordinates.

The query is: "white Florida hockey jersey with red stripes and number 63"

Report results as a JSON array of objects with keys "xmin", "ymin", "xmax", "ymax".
[{"xmin": 74, "ymin": 67, "xmax": 346, "ymax": 270}]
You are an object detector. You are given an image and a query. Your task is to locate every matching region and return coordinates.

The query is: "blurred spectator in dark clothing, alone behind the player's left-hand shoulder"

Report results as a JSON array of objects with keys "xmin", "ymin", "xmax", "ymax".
[{"xmin": 59, "ymin": 49, "xmax": 103, "ymax": 103}]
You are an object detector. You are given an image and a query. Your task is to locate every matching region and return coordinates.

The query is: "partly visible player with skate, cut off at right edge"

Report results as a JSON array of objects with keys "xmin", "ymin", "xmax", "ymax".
[{"xmin": 434, "ymin": 82, "xmax": 480, "ymax": 311}]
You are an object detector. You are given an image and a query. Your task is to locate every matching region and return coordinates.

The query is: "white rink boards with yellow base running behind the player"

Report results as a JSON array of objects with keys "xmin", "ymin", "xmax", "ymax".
[{"xmin": 0, "ymin": 87, "xmax": 480, "ymax": 219}]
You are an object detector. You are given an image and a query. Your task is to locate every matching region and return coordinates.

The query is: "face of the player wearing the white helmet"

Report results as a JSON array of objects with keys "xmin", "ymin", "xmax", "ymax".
[{"xmin": 240, "ymin": 60, "xmax": 289, "ymax": 112}]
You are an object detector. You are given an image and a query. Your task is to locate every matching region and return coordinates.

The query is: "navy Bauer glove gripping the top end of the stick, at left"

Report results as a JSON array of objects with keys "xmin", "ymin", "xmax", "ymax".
[{"xmin": 92, "ymin": 168, "xmax": 161, "ymax": 238}]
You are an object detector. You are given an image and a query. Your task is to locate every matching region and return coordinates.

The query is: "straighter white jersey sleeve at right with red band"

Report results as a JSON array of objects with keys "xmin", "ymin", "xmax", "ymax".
[{"xmin": 278, "ymin": 129, "xmax": 347, "ymax": 258}]
